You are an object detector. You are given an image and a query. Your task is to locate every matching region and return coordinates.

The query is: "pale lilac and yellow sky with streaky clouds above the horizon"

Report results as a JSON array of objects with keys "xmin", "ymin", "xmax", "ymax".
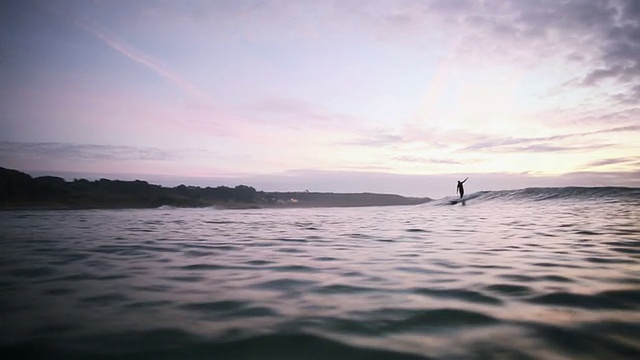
[{"xmin": 0, "ymin": 0, "xmax": 640, "ymax": 198}]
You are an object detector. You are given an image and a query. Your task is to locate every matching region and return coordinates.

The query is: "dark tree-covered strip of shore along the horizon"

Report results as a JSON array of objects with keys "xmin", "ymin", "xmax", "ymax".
[{"xmin": 0, "ymin": 167, "xmax": 430, "ymax": 209}]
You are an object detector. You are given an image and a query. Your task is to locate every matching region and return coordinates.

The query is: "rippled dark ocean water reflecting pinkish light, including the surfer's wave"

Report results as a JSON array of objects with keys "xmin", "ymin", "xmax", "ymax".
[{"xmin": 0, "ymin": 188, "xmax": 640, "ymax": 359}]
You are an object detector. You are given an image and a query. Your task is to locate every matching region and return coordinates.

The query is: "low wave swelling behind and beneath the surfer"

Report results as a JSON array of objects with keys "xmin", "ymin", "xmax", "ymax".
[{"xmin": 432, "ymin": 186, "xmax": 640, "ymax": 205}]
